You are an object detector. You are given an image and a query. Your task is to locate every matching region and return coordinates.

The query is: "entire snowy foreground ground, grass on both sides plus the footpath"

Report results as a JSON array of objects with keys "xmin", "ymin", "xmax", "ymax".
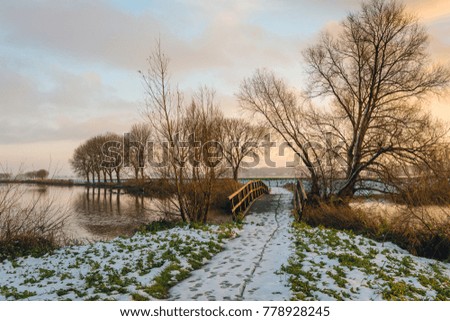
[{"xmin": 0, "ymin": 187, "xmax": 450, "ymax": 300}]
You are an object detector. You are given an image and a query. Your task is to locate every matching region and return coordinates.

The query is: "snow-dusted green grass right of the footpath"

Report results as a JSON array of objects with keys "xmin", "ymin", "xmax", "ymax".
[{"xmin": 283, "ymin": 223, "xmax": 450, "ymax": 300}]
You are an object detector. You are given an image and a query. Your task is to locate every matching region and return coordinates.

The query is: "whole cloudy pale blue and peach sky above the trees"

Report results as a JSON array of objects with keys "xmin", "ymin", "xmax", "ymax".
[{"xmin": 0, "ymin": 0, "xmax": 450, "ymax": 176}]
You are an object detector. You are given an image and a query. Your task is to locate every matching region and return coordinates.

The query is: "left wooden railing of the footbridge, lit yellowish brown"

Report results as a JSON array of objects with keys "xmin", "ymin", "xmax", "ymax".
[{"xmin": 228, "ymin": 180, "xmax": 269, "ymax": 219}]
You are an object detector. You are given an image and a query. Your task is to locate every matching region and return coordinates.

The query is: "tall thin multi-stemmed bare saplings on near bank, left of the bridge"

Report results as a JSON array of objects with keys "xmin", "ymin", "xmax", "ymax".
[{"xmin": 141, "ymin": 42, "xmax": 225, "ymax": 222}]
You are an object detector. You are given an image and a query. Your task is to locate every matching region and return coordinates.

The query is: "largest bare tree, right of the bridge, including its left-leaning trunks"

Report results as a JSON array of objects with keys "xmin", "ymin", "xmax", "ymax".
[{"xmin": 238, "ymin": 0, "xmax": 450, "ymax": 198}]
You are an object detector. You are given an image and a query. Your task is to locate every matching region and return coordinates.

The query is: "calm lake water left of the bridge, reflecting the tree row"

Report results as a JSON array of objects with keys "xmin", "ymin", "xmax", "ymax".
[{"xmin": 6, "ymin": 185, "xmax": 168, "ymax": 242}]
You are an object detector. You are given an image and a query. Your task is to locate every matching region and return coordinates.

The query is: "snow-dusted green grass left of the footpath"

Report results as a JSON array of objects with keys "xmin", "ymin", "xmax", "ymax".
[{"xmin": 0, "ymin": 227, "xmax": 234, "ymax": 300}]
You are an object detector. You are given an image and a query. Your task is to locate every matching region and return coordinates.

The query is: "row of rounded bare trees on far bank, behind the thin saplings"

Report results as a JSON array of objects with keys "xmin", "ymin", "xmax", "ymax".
[{"xmin": 70, "ymin": 105, "xmax": 265, "ymax": 183}]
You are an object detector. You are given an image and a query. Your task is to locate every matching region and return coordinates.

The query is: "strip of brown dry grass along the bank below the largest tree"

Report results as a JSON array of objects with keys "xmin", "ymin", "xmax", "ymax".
[{"xmin": 303, "ymin": 203, "xmax": 450, "ymax": 261}]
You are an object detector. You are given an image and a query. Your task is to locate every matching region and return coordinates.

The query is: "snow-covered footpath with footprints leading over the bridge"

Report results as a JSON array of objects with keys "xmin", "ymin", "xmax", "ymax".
[{"xmin": 170, "ymin": 187, "xmax": 293, "ymax": 300}]
